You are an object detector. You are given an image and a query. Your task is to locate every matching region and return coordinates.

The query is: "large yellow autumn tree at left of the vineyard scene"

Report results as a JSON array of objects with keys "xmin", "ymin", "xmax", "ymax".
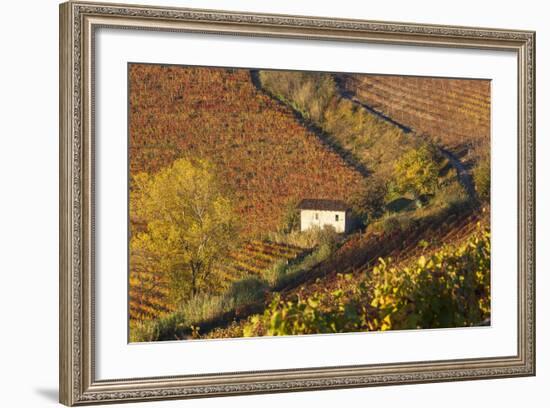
[{"xmin": 130, "ymin": 159, "xmax": 236, "ymax": 302}]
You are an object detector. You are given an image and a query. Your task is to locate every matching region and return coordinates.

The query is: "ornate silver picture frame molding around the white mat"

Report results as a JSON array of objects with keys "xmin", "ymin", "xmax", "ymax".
[{"xmin": 59, "ymin": 2, "xmax": 535, "ymax": 405}]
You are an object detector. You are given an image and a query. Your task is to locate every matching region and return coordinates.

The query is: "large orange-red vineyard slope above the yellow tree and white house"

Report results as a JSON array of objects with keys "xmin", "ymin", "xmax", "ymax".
[{"xmin": 129, "ymin": 64, "xmax": 362, "ymax": 236}]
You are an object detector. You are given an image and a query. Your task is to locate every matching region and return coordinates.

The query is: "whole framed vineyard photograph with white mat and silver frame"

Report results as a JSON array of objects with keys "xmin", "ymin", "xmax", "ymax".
[{"xmin": 60, "ymin": 2, "xmax": 535, "ymax": 405}]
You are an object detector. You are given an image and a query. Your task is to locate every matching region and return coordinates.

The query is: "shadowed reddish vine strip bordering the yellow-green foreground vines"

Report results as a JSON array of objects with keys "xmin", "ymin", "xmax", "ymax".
[{"xmin": 203, "ymin": 207, "xmax": 489, "ymax": 338}]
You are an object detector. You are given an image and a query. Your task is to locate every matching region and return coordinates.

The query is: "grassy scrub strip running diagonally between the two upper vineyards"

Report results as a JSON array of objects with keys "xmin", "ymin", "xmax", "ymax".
[{"xmin": 257, "ymin": 70, "xmax": 419, "ymax": 178}]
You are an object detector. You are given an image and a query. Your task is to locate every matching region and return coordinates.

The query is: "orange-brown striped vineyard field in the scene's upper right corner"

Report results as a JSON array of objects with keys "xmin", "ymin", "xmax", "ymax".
[{"xmin": 336, "ymin": 74, "xmax": 491, "ymax": 159}]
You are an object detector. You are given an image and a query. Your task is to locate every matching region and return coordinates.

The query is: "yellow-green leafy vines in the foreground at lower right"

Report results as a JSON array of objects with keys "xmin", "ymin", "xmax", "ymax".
[{"xmin": 242, "ymin": 225, "xmax": 491, "ymax": 337}]
